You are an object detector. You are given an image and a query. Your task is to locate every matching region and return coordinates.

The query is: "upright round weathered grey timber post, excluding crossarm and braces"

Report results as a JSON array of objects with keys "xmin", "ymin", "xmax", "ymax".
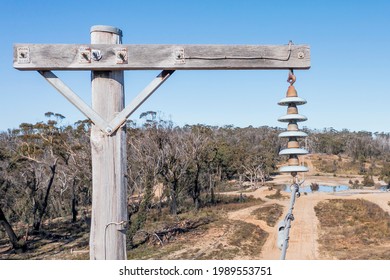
[{"xmin": 90, "ymin": 26, "xmax": 127, "ymax": 260}]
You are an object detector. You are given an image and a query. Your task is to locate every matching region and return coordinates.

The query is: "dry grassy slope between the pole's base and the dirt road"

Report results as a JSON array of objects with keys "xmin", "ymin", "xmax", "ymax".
[{"xmin": 128, "ymin": 210, "xmax": 268, "ymax": 260}]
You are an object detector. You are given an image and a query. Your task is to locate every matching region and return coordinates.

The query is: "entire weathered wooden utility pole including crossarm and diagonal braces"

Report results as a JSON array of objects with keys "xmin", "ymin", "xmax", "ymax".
[{"xmin": 14, "ymin": 26, "xmax": 310, "ymax": 260}]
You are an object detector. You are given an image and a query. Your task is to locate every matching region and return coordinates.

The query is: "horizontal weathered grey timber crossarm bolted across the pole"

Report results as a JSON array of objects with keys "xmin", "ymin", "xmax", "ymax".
[{"xmin": 13, "ymin": 44, "xmax": 310, "ymax": 70}]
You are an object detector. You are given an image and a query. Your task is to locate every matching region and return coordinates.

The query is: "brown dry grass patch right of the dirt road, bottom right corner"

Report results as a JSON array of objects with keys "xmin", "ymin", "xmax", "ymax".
[{"xmin": 315, "ymin": 199, "xmax": 390, "ymax": 259}]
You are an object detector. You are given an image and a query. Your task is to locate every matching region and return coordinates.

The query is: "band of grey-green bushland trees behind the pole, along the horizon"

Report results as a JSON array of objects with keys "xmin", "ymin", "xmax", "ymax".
[{"xmin": 0, "ymin": 112, "xmax": 390, "ymax": 250}]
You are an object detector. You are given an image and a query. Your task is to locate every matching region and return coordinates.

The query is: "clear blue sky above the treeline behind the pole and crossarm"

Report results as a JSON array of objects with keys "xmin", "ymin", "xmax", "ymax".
[{"xmin": 0, "ymin": 0, "xmax": 390, "ymax": 132}]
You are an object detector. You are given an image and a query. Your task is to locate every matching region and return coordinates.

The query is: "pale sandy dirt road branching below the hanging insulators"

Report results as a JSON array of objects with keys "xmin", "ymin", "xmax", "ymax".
[{"xmin": 228, "ymin": 185, "xmax": 390, "ymax": 260}]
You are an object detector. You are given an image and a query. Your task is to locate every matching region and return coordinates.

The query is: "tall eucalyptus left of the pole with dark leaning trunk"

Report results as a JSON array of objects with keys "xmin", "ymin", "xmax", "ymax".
[{"xmin": 6, "ymin": 113, "xmax": 70, "ymax": 231}]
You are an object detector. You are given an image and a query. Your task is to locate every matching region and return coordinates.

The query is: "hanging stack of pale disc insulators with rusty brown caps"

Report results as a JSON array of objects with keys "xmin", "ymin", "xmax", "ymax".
[{"xmin": 278, "ymin": 72, "xmax": 309, "ymax": 176}]
